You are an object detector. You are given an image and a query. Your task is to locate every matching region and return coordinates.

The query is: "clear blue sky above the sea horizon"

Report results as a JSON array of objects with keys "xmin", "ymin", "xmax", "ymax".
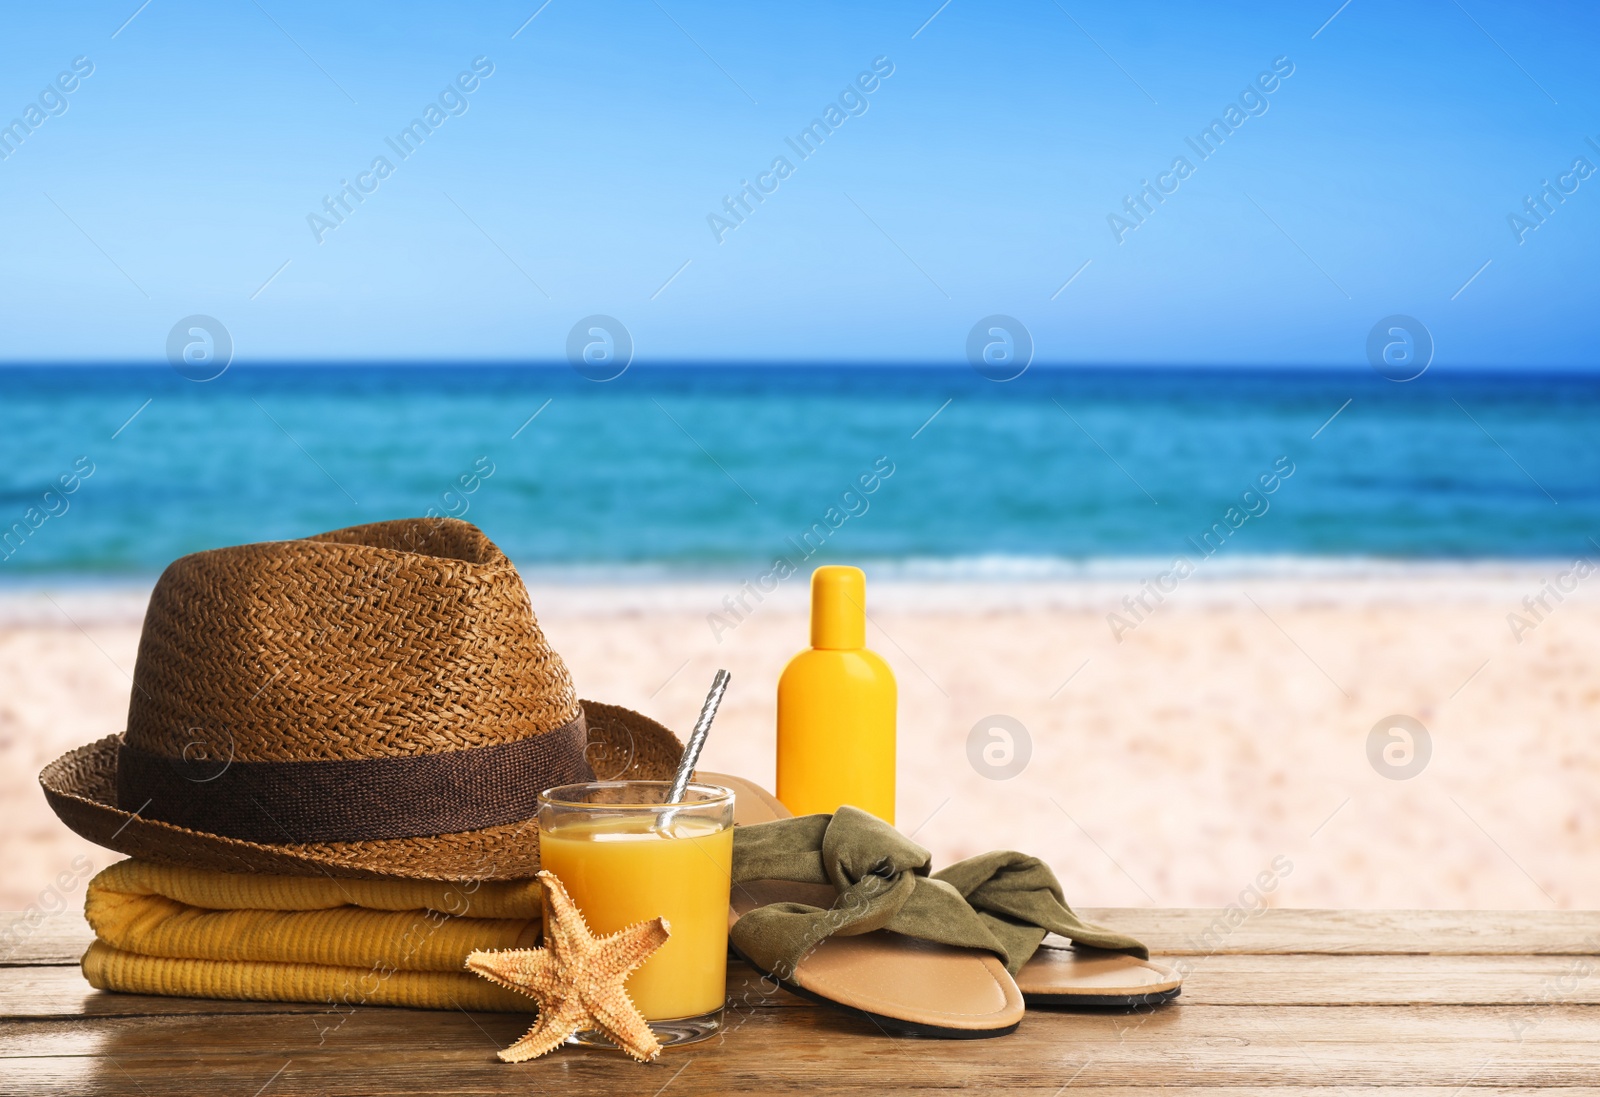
[{"xmin": 0, "ymin": 0, "xmax": 1600, "ymax": 366}]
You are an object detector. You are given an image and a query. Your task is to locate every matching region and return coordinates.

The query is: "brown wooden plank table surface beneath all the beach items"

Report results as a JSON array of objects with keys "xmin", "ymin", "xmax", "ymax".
[{"xmin": 0, "ymin": 910, "xmax": 1600, "ymax": 1097}]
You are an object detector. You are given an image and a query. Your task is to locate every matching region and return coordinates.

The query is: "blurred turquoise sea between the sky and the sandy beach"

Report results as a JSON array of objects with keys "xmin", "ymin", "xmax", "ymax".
[{"xmin": 0, "ymin": 366, "xmax": 1600, "ymax": 580}]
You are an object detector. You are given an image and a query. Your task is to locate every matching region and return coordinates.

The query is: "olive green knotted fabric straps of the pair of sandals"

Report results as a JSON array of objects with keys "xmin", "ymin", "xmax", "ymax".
[{"xmin": 731, "ymin": 808, "xmax": 1150, "ymax": 979}]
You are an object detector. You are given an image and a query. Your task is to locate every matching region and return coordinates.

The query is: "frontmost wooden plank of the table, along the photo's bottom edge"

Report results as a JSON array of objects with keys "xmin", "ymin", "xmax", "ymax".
[{"xmin": 0, "ymin": 1004, "xmax": 1600, "ymax": 1097}]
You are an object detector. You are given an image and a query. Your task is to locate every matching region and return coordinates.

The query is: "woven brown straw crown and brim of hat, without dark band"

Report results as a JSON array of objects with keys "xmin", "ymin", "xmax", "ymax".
[{"xmin": 40, "ymin": 520, "xmax": 682, "ymax": 880}]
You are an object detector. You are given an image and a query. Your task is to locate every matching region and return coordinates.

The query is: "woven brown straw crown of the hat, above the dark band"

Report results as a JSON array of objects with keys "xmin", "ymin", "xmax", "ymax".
[{"xmin": 128, "ymin": 520, "xmax": 578, "ymax": 764}]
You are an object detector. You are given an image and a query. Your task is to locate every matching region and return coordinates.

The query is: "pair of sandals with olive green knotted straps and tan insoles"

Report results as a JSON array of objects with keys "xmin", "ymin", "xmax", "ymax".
[{"xmin": 720, "ymin": 789, "xmax": 1182, "ymax": 1036}]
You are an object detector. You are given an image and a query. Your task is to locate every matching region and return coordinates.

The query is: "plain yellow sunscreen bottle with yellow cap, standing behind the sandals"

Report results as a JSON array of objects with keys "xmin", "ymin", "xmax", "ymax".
[{"xmin": 778, "ymin": 566, "xmax": 898, "ymax": 824}]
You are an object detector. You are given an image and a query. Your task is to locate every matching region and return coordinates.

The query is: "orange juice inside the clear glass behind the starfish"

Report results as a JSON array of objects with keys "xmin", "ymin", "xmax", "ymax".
[{"xmin": 539, "ymin": 814, "xmax": 733, "ymax": 1020}]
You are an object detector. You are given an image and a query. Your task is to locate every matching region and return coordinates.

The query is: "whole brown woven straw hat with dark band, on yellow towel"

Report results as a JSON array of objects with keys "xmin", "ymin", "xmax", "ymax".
[{"xmin": 38, "ymin": 518, "xmax": 682, "ymax": 880}]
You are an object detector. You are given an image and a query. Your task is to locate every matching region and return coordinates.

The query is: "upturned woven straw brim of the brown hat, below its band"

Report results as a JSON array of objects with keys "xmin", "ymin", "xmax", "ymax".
[{"xmin": 38, "ymin": 700, "xmax": 683, "ymax": 881}]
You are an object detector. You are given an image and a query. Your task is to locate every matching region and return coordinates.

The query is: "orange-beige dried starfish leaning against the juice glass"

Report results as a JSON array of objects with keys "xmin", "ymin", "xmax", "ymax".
[{"xmin": 467, "ymin": 872, "xmax": 672, "ymax": 1063}]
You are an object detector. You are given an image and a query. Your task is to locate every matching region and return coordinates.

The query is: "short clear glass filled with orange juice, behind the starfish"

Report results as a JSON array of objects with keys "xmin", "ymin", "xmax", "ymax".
[{"xmin": 539, "ymin": 780, "xmax": 733, "ymax": 1047}]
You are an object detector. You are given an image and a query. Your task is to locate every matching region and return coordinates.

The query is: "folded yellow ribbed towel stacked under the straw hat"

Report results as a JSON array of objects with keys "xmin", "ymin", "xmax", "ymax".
[{"xmin": 83, "ymin": 860, "xmax": 541, "ymax": 1012}]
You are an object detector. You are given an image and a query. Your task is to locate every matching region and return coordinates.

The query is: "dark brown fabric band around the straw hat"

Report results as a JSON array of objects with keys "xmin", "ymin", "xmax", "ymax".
[{"xmin": 117, "ymin": 713, "xmax": 594, "ymax": 844}]
